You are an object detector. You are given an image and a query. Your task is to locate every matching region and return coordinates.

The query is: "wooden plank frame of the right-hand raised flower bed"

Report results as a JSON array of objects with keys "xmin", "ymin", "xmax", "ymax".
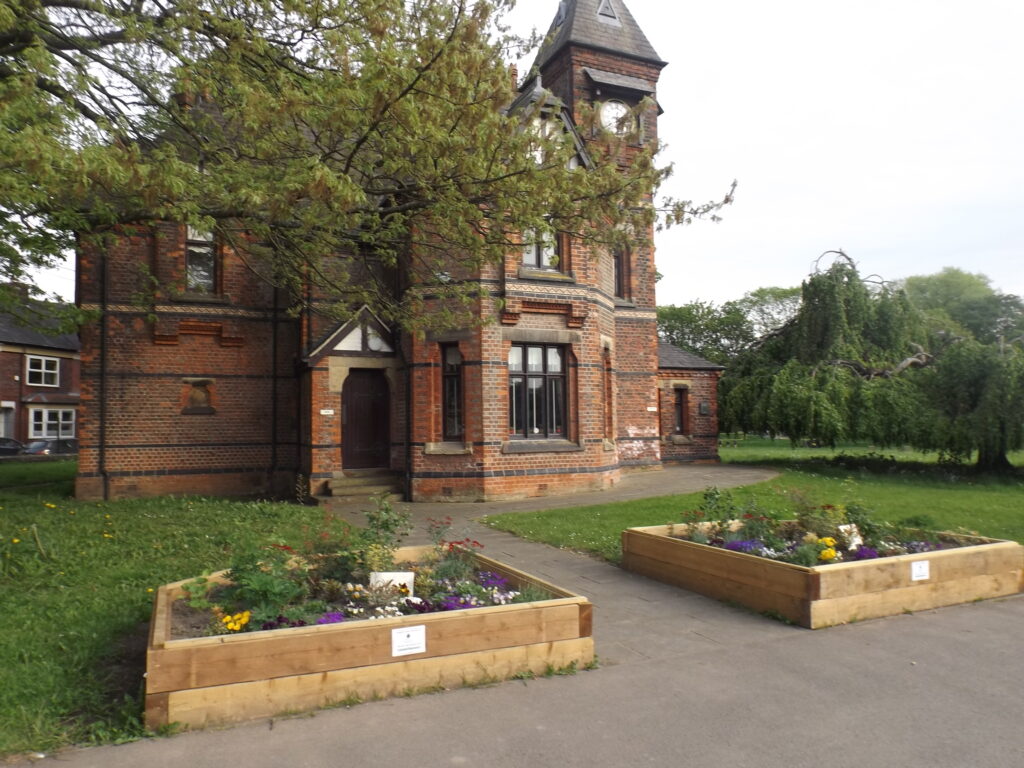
[{"xmin": 623, "ymin": 525, "xmax": 1024, "ymax": 629}]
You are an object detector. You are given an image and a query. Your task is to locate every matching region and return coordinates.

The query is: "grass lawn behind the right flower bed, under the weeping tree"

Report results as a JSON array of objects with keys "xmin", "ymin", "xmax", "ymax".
[{"xmin": 483, "ymin": 439, "xmax": 1024, "ymax": 562}]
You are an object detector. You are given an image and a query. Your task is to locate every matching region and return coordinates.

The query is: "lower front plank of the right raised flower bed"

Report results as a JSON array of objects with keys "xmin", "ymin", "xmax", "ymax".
[{"xmin": 810, "ymin": 572, "xmax": 1020, "ymax": 629}]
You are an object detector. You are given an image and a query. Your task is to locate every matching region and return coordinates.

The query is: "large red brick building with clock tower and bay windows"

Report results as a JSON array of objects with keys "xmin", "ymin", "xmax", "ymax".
[{"xmin": 77, "ymin": 0, "xmax": 703, "ymax": 501}]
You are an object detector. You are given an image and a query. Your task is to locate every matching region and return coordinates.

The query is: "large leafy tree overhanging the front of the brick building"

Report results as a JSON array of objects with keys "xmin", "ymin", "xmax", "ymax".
[{"xmin": 0, "ymin": 0, "xmax": 718, "ymax": 328}]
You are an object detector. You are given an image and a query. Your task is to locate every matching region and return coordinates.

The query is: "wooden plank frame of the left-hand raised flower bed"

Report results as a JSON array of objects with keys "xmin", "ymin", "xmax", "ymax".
[{"xmin": 145, "ymin": 547, "xmax": 594, "ymax": 728}]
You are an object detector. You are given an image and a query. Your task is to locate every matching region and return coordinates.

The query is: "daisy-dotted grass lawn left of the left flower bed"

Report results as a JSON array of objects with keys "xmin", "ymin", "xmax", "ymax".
[{"xmin": 0, "ymin": 461, "xmax": 344, "ymax": 757}]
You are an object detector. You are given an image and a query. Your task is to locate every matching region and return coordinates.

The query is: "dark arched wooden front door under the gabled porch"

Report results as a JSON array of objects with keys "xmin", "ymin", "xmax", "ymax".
[{"xmin": 341, "ymin": 370, "xmax": 391, "ymax": 469}]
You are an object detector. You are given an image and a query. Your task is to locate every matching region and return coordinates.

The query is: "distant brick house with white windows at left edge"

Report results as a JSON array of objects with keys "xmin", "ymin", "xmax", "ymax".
[{"xmin": 0, "ymin": 296, "xmax": 81, "ymax": 442}]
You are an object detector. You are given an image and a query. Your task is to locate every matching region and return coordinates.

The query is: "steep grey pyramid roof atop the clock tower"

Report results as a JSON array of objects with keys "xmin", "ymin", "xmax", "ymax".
[{"xmin": 534, "ymin": 0, "xmax": 666, "ymax": 70}]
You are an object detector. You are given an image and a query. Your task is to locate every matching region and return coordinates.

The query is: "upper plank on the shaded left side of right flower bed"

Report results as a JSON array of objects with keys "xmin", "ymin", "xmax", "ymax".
[{"xmin": 623, "ymin": 526, "xmax": 811, "ymax": 599}]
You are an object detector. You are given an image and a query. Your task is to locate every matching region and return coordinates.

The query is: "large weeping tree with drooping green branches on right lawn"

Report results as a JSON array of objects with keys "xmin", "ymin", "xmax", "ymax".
[{"xmin": 720, "ymin": 252, "xmax": 1024, "ymax": 470}]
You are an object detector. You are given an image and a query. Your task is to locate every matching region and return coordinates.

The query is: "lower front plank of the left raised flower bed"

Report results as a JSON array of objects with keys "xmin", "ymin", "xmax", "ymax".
[{"xmin": 146, "ymin": 638, "xmax": 594, "ymax": 728}]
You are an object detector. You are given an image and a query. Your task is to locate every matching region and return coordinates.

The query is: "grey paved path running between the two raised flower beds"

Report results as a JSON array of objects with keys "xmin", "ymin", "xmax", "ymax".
[{"xmin": 29, "ymin": 466, "xmax": 1024, "ymax": 768}]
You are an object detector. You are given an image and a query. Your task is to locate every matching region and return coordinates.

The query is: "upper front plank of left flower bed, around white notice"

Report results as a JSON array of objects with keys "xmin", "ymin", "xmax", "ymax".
[{"xmin": 146, "ymin": 598, "xmax": 586, "ymax": 693}]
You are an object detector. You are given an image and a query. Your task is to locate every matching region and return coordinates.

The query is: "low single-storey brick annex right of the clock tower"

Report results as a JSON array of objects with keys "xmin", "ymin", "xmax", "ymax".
[{"xmin": 657, "ymin": 341, "xmax": 725, "ymax": 463}]
